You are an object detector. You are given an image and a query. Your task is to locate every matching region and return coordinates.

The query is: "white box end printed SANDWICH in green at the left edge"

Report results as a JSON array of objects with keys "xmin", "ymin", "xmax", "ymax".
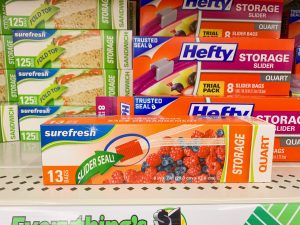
[{"xmin": 0, "ymin": 102, "xmax": 19, "ymax": 143}]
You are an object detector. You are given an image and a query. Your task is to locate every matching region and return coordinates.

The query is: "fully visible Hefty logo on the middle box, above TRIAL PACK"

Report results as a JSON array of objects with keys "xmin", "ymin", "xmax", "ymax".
[{"xmin": 179, "ymin": 43, "xmax": 238, "ymax": 62}]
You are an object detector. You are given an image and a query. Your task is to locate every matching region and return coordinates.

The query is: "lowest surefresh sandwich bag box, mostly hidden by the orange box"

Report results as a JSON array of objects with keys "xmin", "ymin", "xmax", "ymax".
[{"xmin": 18, "ymin": 106, "xmax": 96, "ymax": 142}]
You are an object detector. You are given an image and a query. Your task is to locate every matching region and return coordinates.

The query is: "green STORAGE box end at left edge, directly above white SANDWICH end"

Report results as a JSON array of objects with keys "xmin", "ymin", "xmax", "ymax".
[{"xmin": 0, "ymin": 69, "xmax": 18, "ymax": 102}]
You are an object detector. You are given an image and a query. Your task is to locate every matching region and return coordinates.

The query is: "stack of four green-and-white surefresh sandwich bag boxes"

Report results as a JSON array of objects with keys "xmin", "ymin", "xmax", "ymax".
[{"xmin": 0, "ymin": 0, "xmax": 132, "ymax": 141}]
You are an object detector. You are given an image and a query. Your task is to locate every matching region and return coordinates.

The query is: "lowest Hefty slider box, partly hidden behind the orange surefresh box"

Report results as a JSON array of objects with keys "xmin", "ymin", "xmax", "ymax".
[{"xmin": 96, "ymin": 96, "xmax": 300, "ymax": 162}]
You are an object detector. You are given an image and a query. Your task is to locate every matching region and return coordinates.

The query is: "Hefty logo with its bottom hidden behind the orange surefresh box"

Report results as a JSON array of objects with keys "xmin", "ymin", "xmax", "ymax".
[{"xmin": 189, "ymin": 103, "xmax": 254, "ymax": 117}]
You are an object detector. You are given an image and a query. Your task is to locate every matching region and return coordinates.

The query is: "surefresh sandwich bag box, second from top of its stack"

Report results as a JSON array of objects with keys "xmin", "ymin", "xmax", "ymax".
[{"xmin": 13, "ymin": 30, "xmax": 132, "ymax": 69}]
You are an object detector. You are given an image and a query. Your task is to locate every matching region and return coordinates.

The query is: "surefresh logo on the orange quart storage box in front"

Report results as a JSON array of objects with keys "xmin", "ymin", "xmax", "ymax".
[{"xmin": 45, "ymin": 127, "xmax": 96, "ymax": 137}]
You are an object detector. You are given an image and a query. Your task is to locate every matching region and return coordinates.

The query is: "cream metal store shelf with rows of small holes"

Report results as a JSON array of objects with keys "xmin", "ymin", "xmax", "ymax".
[{"xmin": 0, "ymin": 143, "xmax": 300, "ymax": 206}]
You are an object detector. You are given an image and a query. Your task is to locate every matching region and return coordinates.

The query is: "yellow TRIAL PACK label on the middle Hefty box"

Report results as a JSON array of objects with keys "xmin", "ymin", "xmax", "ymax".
[{"xmin": 197, "ymin": 81, "xmax": 225, "ymax": 96}]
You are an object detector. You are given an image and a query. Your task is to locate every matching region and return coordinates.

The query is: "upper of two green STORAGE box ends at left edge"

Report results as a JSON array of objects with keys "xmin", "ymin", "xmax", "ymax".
[{"xmin": 0, "ymin": 34, "xmax": 15, "ymax": 69}]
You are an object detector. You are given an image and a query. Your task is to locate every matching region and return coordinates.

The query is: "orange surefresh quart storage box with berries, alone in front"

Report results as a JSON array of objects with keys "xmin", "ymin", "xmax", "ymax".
[{"xmin": 41, "ymin": 116, "xmax": 275, "ymax": 185}]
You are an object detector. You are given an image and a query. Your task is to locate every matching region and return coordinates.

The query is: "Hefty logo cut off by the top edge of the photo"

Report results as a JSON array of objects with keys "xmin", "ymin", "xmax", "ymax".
[{"xmin": 182, "ymin": 0, "xmax": 233, "ymax": 11}]
